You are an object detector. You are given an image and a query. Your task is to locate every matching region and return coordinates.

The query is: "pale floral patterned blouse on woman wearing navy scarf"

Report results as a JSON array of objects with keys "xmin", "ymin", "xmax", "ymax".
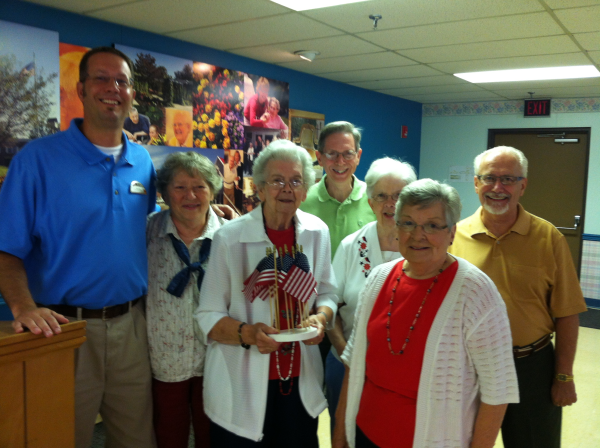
[{"xmin": 146, "ymin": 209, "xmax": 223, "ymax": 382}]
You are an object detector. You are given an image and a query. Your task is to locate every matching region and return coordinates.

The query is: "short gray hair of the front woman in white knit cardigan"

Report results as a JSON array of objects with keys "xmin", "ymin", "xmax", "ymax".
[{"xmin": 395, "ymin": 179, "xmax": 462, "ymax": 227}]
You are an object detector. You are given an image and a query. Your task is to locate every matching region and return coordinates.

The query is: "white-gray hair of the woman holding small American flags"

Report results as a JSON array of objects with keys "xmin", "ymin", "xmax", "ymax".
[{"xmin": 252, "ymin": 139, "xmax": 315, "ymax": 188}]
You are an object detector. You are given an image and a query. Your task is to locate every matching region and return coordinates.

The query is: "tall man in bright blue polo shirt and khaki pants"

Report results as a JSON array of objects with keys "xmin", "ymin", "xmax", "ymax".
[{"xmin": 0, "ymin": 47, "xmax": 156, "ymax": 448}]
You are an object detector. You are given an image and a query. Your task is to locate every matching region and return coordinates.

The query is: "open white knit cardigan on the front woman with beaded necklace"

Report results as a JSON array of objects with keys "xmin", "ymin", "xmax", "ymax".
[{"xmin": 342, "ymin": 257, "xmax": 519, "ymax": 448}]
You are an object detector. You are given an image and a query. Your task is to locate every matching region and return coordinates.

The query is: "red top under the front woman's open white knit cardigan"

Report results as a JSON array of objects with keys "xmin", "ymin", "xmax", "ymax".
[{"xmin": 356, "ymin": 260, "xmax": 458, "ymax": 448}]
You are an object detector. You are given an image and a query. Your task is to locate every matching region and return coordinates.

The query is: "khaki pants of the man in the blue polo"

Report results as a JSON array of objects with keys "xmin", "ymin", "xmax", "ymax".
[{"xmin": 69, "ymin": 301, "xmax": 156, "ymax": 448}]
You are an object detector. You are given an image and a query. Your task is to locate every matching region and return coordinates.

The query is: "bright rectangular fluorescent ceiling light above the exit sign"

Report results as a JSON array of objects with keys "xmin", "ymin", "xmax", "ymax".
[{"xmin": 454, "ymin": 65, "xmax": 600, "ymax": 84}]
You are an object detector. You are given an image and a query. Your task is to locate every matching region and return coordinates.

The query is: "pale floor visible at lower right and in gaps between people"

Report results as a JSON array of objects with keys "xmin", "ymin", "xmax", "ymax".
[{"xmin": 319, "ymin": 327, "xmax": 600, "ymax": 448}]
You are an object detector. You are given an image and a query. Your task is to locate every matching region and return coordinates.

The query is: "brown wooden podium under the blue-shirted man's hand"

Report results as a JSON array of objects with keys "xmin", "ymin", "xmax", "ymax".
[{"xmin": 0, "ymin": 321, "xmax": 86, "ymax": 448}]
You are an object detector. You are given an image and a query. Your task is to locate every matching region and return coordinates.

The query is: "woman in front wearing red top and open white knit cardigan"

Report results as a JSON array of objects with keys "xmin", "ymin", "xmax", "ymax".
[{"xmin": 333, "ymin": 179, "xmax": 519, "ymax": 448}]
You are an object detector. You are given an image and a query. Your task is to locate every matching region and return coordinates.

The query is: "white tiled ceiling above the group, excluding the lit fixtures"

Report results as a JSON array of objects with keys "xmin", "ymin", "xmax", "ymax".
[{"xmin": 25, "ymin": 0, "xmax": 600, "ymax": 103}]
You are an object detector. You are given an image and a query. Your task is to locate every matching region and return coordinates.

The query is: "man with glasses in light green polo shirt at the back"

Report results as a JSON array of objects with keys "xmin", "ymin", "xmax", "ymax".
[{"xmin": 300, "ymin": 121, "xmax": 375, "ymax": 259}]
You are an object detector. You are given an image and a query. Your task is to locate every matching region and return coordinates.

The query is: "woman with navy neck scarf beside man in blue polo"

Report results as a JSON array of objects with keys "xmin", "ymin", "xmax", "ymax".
[{"xmin": 146, "ymin": 151, "xmax": 223, "ymax": 448}]
